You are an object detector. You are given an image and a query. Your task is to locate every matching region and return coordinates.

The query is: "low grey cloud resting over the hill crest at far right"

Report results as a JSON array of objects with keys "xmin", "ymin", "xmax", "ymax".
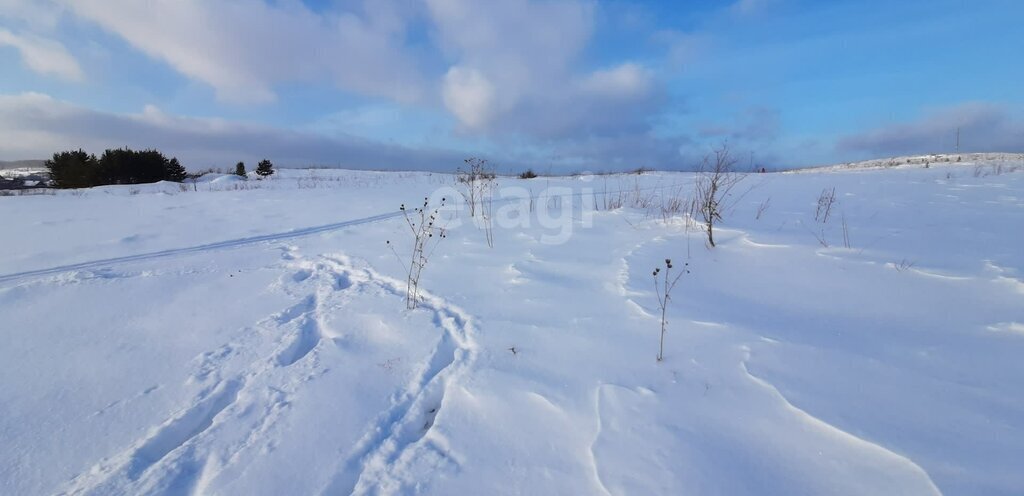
[{"xmin": 836, "ymin": 102, "xmax": 1024, "ymax": 157}]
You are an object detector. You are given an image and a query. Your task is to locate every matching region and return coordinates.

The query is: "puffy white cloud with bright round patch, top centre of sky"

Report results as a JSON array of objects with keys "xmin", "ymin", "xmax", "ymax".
[{"xmin": 427, "ymin": 0, "xmax": 660, "ymax": 140}]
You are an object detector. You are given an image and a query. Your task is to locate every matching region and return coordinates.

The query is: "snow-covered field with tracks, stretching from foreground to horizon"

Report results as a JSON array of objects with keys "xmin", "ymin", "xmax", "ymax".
[{"xmin": 0, "ymin": 162, "xmax": 1024, "ymax": 495}]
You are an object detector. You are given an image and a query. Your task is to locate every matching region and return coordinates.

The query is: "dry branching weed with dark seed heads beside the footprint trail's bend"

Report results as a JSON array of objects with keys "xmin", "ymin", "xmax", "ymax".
[{"xmin": 387, "ymin": 198, "xmax": 447, "ymax": 309}]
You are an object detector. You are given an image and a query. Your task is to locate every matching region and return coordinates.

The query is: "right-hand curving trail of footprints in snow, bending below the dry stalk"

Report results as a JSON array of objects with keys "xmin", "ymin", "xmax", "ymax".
[{"xmin": 322, "ymin": 258, "xmax": 476, "ymax": 494}]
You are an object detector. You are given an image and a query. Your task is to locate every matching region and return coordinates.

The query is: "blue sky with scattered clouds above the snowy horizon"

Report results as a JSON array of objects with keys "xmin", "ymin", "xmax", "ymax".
[{"xmin": 0, "ymin": 0, "xmax": 1024, "ymax": 172}]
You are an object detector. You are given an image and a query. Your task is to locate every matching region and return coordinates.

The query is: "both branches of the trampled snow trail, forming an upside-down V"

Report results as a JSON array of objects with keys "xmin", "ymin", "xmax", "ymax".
[{"xmin": 62, "ymin": 249, "xmax": 475, "ymax": 494}]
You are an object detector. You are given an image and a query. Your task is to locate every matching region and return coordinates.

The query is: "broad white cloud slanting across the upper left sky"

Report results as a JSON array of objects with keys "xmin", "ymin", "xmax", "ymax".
[{"xmin": 62, "ymin": 0, "xmax": 423, "ymax": 102}]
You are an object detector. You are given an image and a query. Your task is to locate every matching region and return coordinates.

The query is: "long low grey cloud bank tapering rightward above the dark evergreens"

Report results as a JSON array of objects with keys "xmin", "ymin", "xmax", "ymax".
[{"xmin": 0, "ymin": 93, "xmax": 464, "ymax": 170}]
